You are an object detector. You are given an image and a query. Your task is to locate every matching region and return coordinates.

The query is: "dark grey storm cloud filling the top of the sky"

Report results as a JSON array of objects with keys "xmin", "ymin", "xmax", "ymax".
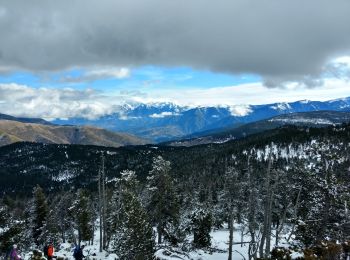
[{"xmin": 0, "ymin": 0, "xmax": 350, "ymax": 82}]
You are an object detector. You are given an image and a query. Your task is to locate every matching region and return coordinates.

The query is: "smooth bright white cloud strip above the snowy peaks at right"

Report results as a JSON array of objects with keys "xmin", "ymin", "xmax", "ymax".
[{"xmin": 134, "ymin": 78, "xmax": 350, "ymax": 108}]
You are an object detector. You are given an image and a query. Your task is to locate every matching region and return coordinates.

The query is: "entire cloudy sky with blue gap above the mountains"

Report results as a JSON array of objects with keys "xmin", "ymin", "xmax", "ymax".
[{"xmin": 0, "ymin": 0, "xmax": 350, "ymax": 118}]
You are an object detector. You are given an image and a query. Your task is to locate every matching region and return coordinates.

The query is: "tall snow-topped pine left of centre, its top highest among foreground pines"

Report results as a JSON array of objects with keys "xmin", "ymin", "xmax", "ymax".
[{"xmin": 147, "ymin": 156, "xmax": 179, "ymax": 244}]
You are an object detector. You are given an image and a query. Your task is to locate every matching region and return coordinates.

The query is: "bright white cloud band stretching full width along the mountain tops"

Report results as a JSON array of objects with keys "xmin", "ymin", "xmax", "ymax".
[{"xmin": 0, "ymin": 78, "xmax": 350, "ymax": 119}]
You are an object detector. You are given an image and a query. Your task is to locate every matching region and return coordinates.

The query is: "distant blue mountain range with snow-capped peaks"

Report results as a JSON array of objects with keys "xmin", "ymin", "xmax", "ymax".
[{"xmin": 52, "ymin": 97, "xmax": 350, "ymax": 142}]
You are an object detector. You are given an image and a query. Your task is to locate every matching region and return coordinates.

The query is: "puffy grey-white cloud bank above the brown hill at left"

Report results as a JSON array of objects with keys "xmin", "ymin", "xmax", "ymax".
[{"xmin": 0, "ymin": 84, "xmax": 120, "ymax": 119}]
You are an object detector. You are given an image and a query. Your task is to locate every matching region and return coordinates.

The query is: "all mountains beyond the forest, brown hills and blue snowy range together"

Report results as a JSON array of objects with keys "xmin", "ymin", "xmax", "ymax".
[{"xmin": 0, "ymin": 98, "xmax": 350, "ymax": 147}]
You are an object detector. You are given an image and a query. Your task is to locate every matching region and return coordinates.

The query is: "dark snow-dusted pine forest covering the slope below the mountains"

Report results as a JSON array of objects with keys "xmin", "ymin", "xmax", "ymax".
[{"xmin": 0, "ymin": 125, "xmax": 350, "ymax": 259}]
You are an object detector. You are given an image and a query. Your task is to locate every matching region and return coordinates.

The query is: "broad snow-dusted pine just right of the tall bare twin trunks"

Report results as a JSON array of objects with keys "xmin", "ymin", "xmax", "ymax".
[{"xmin": 109, "ymin": 170, "xmax": 154, "ymax": 260}]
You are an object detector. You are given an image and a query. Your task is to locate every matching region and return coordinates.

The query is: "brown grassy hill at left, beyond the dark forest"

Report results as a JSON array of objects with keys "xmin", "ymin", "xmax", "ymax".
[{"xmin": 0, "ymin": 117, "xmax": 150, "ymax": 147}]
